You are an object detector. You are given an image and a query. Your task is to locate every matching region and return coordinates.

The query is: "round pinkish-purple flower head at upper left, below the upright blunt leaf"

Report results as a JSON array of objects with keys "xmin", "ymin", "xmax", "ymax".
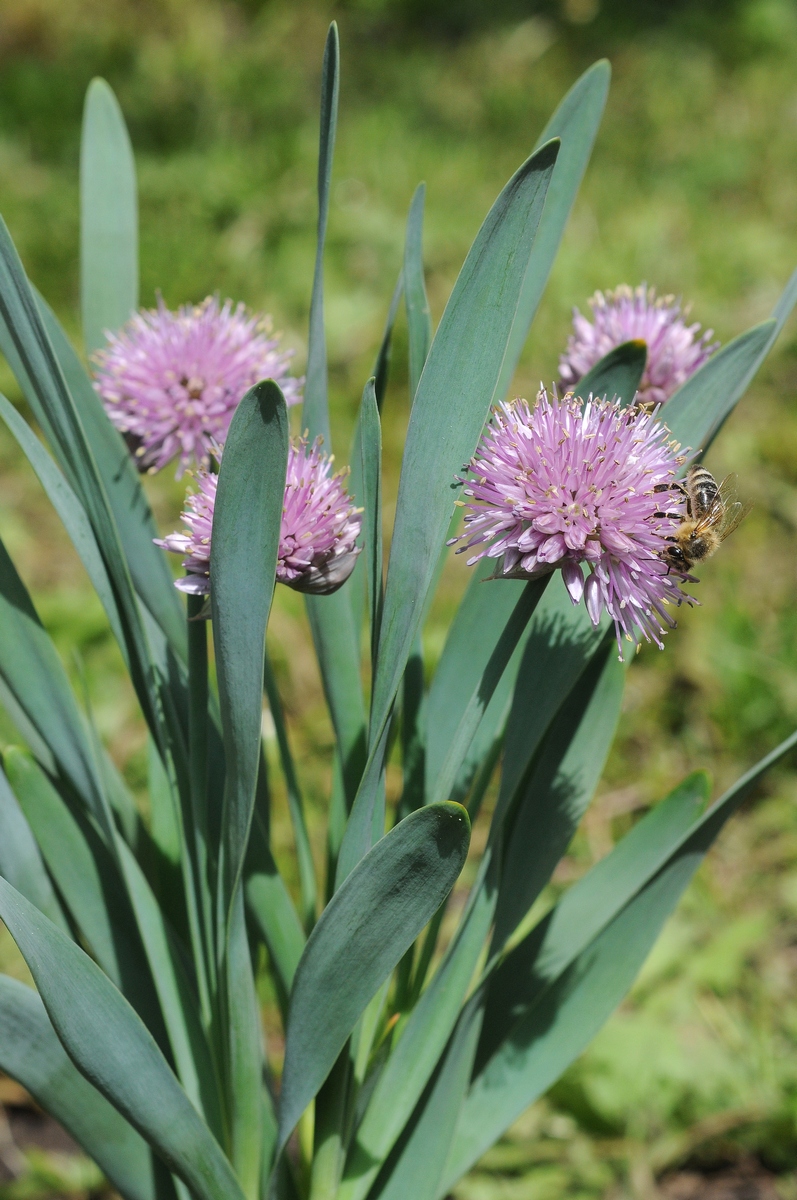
[{"xmin": 95, "ymin": 296, "xmax": 301, "ymax": 478}]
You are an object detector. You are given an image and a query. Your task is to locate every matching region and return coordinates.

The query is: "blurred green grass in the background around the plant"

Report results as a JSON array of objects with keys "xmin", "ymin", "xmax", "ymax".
[{"xmin": 0, "ymin": 0, "xmax": 797, "ymax": 1200}]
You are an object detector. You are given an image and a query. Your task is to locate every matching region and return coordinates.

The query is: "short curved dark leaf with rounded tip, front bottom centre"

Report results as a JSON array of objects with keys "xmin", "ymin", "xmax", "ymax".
[{"xmin": 280, "ymin": 804, "xmax": 471, "ymax": 1146}]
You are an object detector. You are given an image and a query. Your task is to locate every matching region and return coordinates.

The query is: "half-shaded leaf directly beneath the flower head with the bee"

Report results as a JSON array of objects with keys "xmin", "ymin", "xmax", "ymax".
[{"xmin": 492, "ymin": 646, "xmax": 625, "ymax": 953}]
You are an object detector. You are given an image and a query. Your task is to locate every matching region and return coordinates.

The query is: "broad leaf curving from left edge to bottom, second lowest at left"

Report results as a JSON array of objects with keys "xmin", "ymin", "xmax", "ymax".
[{"xmin": 0, "ymin": 880, "xmax": 242, "ymax": 1200}]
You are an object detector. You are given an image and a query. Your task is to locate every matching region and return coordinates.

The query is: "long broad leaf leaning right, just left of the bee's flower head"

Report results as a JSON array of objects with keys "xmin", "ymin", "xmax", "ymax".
[{"xmin": 338, "ymin": 142, "xmax": 558, "ymax": 878}]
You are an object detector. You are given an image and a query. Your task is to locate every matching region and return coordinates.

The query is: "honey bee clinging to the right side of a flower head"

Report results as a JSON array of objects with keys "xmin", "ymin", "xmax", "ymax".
[{"xmin": 654, "ymin": 467, "xmax": 751, "ymax": 572}]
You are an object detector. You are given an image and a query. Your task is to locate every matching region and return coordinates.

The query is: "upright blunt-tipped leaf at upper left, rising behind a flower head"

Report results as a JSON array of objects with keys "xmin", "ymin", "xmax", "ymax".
[{"xmin": 80, "ymin": 79, "xmax": 138, "ymax": 354}]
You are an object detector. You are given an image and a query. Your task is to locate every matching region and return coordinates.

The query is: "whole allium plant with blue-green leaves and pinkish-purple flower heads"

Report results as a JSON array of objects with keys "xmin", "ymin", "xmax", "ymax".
[{"xmin": 0, "ymin": 35, "xmax": 797, "ymax": 1200}]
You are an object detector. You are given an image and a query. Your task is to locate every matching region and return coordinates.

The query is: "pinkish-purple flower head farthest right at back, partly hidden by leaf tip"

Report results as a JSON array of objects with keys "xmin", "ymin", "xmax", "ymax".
[{"xmin": 559, "ymin": 283, "xmax": 719, "ymax": 407}]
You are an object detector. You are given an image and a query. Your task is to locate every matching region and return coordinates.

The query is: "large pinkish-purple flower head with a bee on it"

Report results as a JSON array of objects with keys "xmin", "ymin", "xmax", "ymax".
[{"xmin": 454, "ymin": 389, "xmax": 694, "ymax": 658}]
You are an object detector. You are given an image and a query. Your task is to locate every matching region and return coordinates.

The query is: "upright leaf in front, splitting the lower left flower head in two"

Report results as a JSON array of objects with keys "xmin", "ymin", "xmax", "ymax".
[{"xmin": 210, "ymin": 380, "xmax": 288, "ymax": 1200}]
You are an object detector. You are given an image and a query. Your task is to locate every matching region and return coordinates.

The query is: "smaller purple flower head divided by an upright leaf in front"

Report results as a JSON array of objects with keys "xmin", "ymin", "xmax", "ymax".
[{"xmin": 156, "ymin": 439, "xmax": 360, "ymax": 595}]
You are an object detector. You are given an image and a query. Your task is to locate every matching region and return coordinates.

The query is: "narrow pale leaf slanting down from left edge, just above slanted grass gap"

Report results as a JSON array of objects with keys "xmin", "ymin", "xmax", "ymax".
[{"xmin": 0, "ymin": 395, "xmax": 126, "ymax": 654}]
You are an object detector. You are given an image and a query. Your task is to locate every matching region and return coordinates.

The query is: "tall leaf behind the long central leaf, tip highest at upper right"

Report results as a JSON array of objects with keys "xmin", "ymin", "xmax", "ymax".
[{"xmin": 499, "ymin": 59, "xmax": 611, "ymax": 398}]
